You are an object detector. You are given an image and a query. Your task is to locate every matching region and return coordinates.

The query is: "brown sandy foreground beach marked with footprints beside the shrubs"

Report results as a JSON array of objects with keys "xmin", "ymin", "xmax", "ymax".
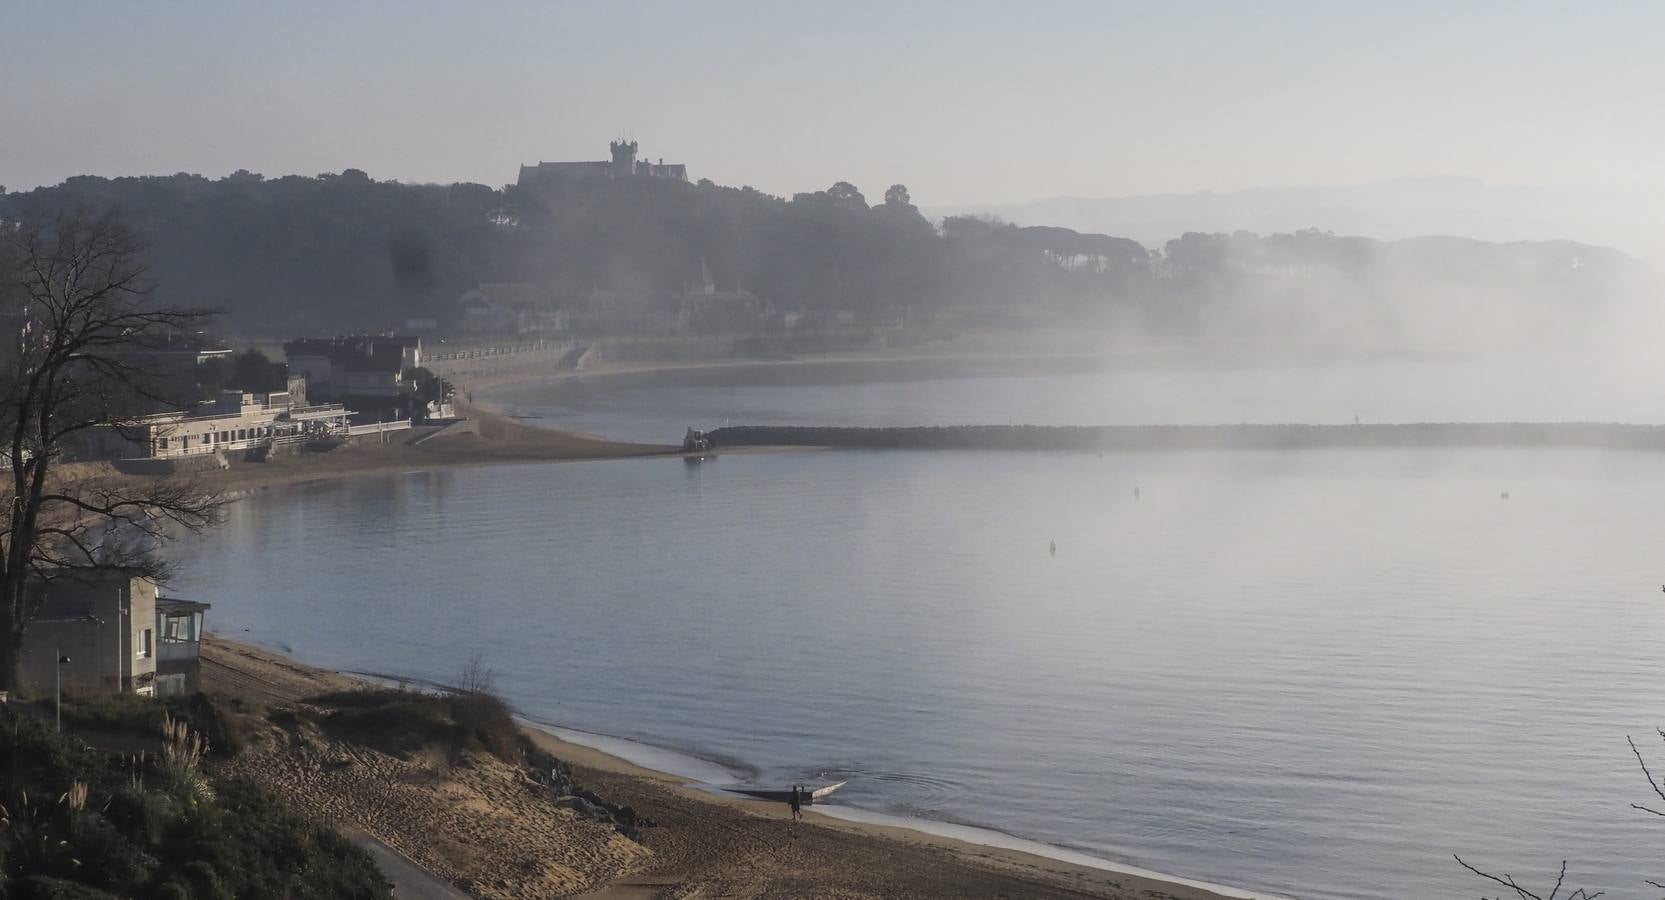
[{"xmin": 203, "ymin": 637, "xmax": 1252, "ymax": 900}]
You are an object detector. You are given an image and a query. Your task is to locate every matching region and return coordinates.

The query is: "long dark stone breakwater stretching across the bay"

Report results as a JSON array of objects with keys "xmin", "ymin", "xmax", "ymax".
[{"xmin": 709, "ymin": 423, "xmax": 1665, "ymax": 452}]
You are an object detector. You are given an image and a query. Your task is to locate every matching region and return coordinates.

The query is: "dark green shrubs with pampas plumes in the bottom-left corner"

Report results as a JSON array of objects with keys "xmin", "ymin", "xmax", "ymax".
[{"xmin": 0, "ymin": 709, "xmax": 391, "ymax": 900}]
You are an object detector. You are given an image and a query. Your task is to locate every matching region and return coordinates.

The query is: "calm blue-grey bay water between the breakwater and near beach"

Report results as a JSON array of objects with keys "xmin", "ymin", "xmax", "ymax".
[{"xmin": 173, "ymin": 360, "xmax": 1665, "ymax": 898}]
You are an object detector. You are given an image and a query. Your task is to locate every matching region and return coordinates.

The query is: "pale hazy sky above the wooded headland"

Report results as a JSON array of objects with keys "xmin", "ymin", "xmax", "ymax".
[{"xmin": 0, "ymin": 0, "xmax": 1665, "ymax": 205}]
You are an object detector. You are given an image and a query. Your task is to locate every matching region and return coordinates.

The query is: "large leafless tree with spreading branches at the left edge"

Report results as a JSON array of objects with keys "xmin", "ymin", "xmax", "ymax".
[{"xmin": 0, "ymin": 215, "xmax": 223, "ymax": 690}]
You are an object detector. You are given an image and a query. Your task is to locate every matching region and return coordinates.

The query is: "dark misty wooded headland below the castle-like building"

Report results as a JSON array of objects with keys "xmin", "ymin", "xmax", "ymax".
[{"xmin": 0, "ymin": 170, "xmax": 1635, "ymax": 341}]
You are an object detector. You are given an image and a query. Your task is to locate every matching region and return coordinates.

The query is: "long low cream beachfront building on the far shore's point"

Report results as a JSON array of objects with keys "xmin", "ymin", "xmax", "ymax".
[{"xmin": 77, "ymin": 391, "xmax": 351, "ymax": 459}]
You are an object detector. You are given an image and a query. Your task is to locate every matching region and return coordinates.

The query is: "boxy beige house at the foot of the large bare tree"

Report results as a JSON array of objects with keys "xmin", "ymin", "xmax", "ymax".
[{"xmin": 20, "ymin": 571, "xmax": 157, "ymax": 695}]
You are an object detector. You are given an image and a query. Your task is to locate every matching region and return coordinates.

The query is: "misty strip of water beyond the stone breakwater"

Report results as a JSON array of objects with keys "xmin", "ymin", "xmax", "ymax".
[{"xmin": 480, "ymin": 351, "xmax": 1665, "ymax": 443}]
